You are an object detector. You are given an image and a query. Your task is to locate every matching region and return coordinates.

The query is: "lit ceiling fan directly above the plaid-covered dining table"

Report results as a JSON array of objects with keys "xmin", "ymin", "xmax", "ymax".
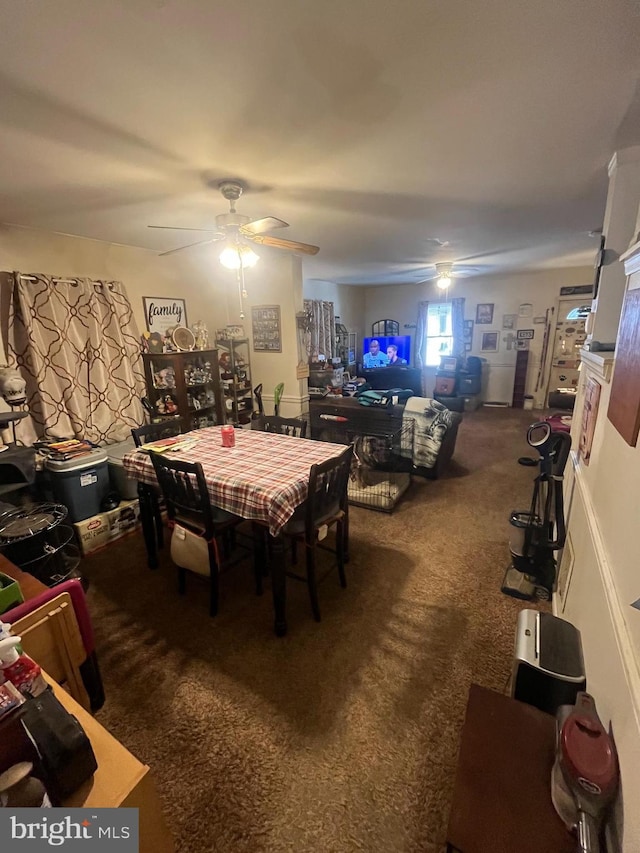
[{"xmin": 148, "ymin": 180, "xmax": 319, "ymax": 260}]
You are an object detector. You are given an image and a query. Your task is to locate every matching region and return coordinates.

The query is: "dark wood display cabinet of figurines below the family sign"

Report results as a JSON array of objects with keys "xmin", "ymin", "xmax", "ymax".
[{"xmin": 143, "ymin": 349, "xmax": 225, "ymax": 432}]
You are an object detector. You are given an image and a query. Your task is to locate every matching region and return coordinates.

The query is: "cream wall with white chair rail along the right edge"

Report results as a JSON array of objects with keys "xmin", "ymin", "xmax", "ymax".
[{"xmin": 554, "ymin": 255, "xmax": 640, "ymax": 853}]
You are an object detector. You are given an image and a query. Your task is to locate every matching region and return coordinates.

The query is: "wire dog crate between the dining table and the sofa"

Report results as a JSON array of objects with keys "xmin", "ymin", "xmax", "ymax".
[{"xmin": 312, "ymin": 418, "xmax": 415, "ymax": 512}]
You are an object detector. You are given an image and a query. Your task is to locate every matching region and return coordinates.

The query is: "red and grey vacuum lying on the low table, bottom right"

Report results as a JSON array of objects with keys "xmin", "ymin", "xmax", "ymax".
[{"xmin": 551, "ymin": 692, "xmax": 620, "ymax": 853}]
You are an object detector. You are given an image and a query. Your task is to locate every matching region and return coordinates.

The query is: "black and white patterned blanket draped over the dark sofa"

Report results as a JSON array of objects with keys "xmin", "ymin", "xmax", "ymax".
[{"xmin": 400, "ymin": 397, "xmax": 455, "ymax": 468}]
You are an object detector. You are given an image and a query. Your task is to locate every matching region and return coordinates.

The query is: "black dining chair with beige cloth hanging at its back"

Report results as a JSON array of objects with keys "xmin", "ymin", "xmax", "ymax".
[{"xmin": 151, "ymin": 452, "xmax": 262, "ymax": 616}]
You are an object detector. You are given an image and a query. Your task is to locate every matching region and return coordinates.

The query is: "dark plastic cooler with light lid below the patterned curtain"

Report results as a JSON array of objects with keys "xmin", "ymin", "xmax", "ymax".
[{"xmin": 44, "ymin": 447, "xmax": 110, "ymax": 522}]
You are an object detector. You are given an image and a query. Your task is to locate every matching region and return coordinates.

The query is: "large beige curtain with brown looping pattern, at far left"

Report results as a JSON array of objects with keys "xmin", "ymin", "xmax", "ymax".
[{"xmin": 7, "ymin": 272, "xmax": 145, "ymax": 444}]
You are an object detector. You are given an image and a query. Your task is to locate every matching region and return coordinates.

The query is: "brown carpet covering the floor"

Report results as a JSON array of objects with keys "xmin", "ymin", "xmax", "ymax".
[{"xmin": 84, "ymin": 409, "xmax": 535, "ymax": 853}]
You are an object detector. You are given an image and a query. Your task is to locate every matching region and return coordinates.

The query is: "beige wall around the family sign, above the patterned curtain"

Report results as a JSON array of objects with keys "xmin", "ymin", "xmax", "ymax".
[{"xmin": 0, "ymin": 225, "xmax": 306, "ymax": 414}]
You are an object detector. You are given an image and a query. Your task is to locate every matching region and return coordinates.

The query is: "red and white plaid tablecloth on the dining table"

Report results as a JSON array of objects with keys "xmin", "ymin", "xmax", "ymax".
[{"xmin": 123, "ymin": 427, "xmax": 345, "ymax": 536}]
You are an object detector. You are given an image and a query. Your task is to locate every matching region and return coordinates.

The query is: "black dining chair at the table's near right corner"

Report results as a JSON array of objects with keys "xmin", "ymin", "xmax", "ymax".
[{"xmin": 283, "ymin": 445, "xmax": 353, "ymax": 622}]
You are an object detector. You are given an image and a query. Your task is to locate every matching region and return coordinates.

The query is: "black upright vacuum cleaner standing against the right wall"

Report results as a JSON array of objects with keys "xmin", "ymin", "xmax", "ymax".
[{"xmin": 502, "ymin": 421, "xmax": 571, "ymax": 601}]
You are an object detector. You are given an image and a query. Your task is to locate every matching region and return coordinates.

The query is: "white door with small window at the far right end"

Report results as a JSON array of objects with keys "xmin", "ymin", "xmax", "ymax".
[{"xmin": 547, "ymin": 299, "xmax": 591, "ymax": 405}]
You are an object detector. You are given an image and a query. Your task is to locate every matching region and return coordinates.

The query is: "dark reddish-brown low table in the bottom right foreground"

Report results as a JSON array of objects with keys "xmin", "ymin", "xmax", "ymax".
[{"xmin": 447, "ymin": 684, "xmax": 577, "ymax": 853}]
